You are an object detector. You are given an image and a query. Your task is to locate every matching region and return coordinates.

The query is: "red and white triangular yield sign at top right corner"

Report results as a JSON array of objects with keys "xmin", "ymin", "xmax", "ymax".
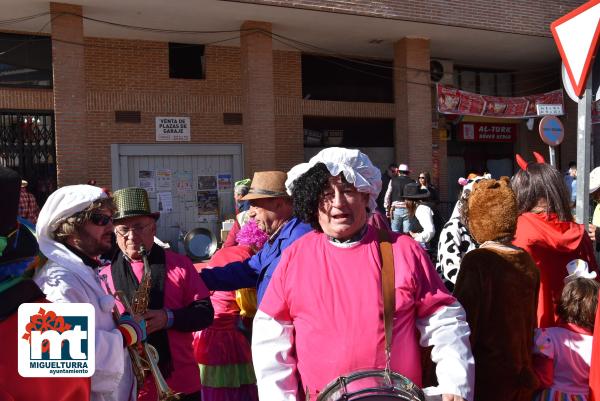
[{"xmin": 550, "ymin": 0, "xmax": 600, "ymax": 96}]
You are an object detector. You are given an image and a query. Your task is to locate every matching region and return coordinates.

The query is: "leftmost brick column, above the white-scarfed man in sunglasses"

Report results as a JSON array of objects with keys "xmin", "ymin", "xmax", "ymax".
[{"xmin": 50, "ymin": 3, "xmax": 90, "ymax": 186}]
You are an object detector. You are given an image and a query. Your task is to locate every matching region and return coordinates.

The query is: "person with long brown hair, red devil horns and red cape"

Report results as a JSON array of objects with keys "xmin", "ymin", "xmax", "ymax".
[{"xmin": 512, "ymin": 152, "xmax": 598, "ymax": 327}]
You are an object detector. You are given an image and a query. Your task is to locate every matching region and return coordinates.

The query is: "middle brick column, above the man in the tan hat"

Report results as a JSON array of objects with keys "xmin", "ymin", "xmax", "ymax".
[{"xmin": 240, "ymin": 21, "xmax": 277, "ymax": 176}]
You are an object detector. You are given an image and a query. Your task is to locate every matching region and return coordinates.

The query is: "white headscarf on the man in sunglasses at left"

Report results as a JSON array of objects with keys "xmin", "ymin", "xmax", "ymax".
[{"xmin": 35, "ymin": 185, "xmax": 108, "ymax": 261}]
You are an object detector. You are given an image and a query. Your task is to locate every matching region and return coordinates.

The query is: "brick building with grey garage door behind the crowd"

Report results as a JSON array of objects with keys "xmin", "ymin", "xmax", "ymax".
[{"xmin": 0, "ymin": 0, "xmax": 583, "ymax": 238}]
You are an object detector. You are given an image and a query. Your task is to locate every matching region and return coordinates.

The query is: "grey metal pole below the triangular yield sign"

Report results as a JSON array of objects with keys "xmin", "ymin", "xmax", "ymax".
[{"xmin": 575, "ymin": 73, "xmax": 593, "ymax": 228}]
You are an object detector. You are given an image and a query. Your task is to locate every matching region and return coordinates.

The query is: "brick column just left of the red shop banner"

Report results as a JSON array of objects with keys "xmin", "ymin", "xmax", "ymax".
[{"xmin": 394, "ymin": 38, "xmax": 433, "ymax": 174}]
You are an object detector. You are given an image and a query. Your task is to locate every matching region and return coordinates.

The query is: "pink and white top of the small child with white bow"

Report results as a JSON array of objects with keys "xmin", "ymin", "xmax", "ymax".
[{"xmin": 534, "ymin": 324, "xmax": 593, "ymax": 400}]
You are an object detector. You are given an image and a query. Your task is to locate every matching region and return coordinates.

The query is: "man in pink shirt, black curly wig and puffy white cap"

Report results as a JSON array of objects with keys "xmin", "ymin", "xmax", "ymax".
[{"xmin": 252, "ymin": 148, "xmax": 474, "ymax": 401}]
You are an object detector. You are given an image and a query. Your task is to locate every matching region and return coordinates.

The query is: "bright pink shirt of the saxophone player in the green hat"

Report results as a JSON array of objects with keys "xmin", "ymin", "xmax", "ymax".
[{"xmin": 100, "ymin": 250, "xmax": 209, "ymax": 401}]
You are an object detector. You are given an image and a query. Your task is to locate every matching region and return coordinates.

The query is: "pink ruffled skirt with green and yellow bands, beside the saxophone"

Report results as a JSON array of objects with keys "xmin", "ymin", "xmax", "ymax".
[{"xmin": 194, "ymin": 315, "xmax": 258, "ymax": 401}]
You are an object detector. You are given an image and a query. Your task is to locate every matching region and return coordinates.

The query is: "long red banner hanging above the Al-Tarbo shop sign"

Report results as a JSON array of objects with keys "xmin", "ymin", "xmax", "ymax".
[{"xmin": 437, "ymin": 84, "xmax": 564, "ymax": 118}]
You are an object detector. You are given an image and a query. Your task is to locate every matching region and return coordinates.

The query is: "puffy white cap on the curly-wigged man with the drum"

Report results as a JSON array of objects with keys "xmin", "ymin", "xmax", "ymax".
[{"xmin": 285, "ymin": 148, "xmax": 381, "ymax": 213}]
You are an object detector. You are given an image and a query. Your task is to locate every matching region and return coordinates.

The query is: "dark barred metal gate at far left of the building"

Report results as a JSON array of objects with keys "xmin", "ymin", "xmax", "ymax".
[{"xmin": 0, "ymin": 110, "xmax": 56, "ymax": 207}]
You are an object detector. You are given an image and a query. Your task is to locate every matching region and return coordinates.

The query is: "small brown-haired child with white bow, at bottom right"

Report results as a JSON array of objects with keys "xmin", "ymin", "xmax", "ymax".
[{"xmin": 534, "ymin": 259, "xmax": 600, "ymax": 401}]
